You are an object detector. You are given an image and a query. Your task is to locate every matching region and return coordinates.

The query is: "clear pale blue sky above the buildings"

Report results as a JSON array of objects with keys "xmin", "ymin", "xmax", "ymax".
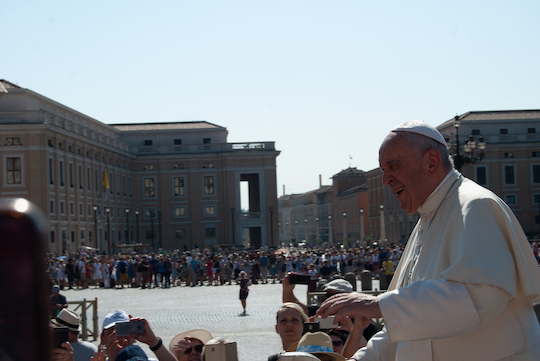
[{"xmin": 4, "ymin": 0, "xmax": 540, "ymax": 196}]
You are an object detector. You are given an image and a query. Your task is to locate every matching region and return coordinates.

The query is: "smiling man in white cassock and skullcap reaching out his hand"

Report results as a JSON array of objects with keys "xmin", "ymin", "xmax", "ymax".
[{"xmin": 318, "ymin": 121, "xmax": 540, "ymax": 361}]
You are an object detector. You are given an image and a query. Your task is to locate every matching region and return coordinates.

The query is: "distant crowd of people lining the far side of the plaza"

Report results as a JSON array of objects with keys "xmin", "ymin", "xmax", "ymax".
[{"xmin": 47, "ymin": 246, "xmax": 403, "ymax": 289}]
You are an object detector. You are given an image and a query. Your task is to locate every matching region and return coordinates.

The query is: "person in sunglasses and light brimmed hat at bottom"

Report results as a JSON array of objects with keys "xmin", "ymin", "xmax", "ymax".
[{"xmin": 169, "ymin": 330, "xmax": 214, "ymax": 361}]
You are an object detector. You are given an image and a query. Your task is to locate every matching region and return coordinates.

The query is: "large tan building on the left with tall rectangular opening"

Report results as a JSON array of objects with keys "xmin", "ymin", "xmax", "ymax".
[{"xmin": 0, "ymin": 80, "xmax": 279, "ymax": 254}]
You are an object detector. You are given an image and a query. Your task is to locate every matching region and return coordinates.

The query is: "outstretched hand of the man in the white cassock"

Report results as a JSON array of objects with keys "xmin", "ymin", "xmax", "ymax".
[{"xmin": 316, "ymin": 292, "xmax": 382, "ymax": 322}]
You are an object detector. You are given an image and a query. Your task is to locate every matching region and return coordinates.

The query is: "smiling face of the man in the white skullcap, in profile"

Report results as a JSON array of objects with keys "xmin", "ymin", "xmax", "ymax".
[{"xmin": 379, "ymin": 133, "xmax": 430, "ymax": 214}]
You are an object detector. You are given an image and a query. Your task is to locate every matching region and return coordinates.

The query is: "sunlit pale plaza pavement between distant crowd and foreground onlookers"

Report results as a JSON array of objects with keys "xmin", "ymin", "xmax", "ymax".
[{"xmin": 61, "ymin": 281, "xmax": 378, "ymax": 361}]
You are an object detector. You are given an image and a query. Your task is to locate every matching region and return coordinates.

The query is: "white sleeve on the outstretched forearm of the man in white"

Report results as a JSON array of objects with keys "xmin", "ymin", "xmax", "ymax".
[{"xmin": 378, "ymin": 279, "xmax": 511, "ymax": 342}]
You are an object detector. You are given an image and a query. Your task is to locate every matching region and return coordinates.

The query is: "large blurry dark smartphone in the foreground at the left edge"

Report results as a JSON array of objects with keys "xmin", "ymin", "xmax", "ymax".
[{"xmin": 0, "ymin": 198, "xmax": 52, "ymax": 361}]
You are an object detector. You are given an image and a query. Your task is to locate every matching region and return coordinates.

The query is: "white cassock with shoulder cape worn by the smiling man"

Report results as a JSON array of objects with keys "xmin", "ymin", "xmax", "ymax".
[{"xmin": 353, "ymin": 170, "xmax": 540, "ymax": 361}]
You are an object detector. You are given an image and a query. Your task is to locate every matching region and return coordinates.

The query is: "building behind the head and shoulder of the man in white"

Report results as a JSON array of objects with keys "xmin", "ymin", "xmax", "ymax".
[{"xmin": 437, "ymin": 110, "xmax": 540, "ymax": 237}]
